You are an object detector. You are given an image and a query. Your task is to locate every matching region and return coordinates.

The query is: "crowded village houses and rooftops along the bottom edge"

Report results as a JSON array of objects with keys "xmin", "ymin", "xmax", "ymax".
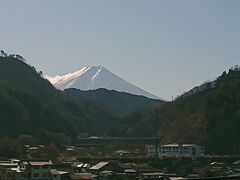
[{"xmin": 0, "ymin": 154, "xmax": 240, "ymax": 180}]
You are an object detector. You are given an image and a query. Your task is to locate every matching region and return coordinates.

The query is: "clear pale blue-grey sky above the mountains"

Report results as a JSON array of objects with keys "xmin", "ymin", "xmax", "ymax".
[{"xmin": 0, "ymin": 0, "xmax": 240, "ymax": 99}]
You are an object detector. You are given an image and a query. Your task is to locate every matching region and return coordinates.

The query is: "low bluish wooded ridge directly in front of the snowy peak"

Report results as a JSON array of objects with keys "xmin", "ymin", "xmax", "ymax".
[{"xmin": 63, "ymin": 88, "xmax": 164, "ymax": 114}]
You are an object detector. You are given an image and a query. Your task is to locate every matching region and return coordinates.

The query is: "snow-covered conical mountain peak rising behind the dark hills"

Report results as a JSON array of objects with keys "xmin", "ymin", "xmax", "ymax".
[{"xmin": 45, "ymin": 66, "xmax": 161, "ymax": 99}]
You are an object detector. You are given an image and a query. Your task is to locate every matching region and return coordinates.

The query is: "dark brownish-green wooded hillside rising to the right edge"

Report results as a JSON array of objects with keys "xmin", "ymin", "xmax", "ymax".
[{"xmin": 109, "ymin": 68, "xmax": 240, "ymax": 154}]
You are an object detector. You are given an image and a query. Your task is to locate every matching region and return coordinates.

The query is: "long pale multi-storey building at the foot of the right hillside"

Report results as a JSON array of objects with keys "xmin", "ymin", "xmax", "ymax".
[{"xmin": 146, "ymin": 144, "xmax": 205, "ymax": 157}]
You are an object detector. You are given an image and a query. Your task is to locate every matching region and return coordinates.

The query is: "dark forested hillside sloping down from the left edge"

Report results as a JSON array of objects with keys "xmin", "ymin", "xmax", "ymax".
[{"xmin": 0, "ymin": 57, "xmax": 119, "ymax": 142}]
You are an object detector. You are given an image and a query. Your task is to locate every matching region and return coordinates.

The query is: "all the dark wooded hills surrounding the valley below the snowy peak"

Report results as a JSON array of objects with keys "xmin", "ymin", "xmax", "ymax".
[{"xmin": 0, "ymin": 53, "xmax": 240, "ymax": 156}]
